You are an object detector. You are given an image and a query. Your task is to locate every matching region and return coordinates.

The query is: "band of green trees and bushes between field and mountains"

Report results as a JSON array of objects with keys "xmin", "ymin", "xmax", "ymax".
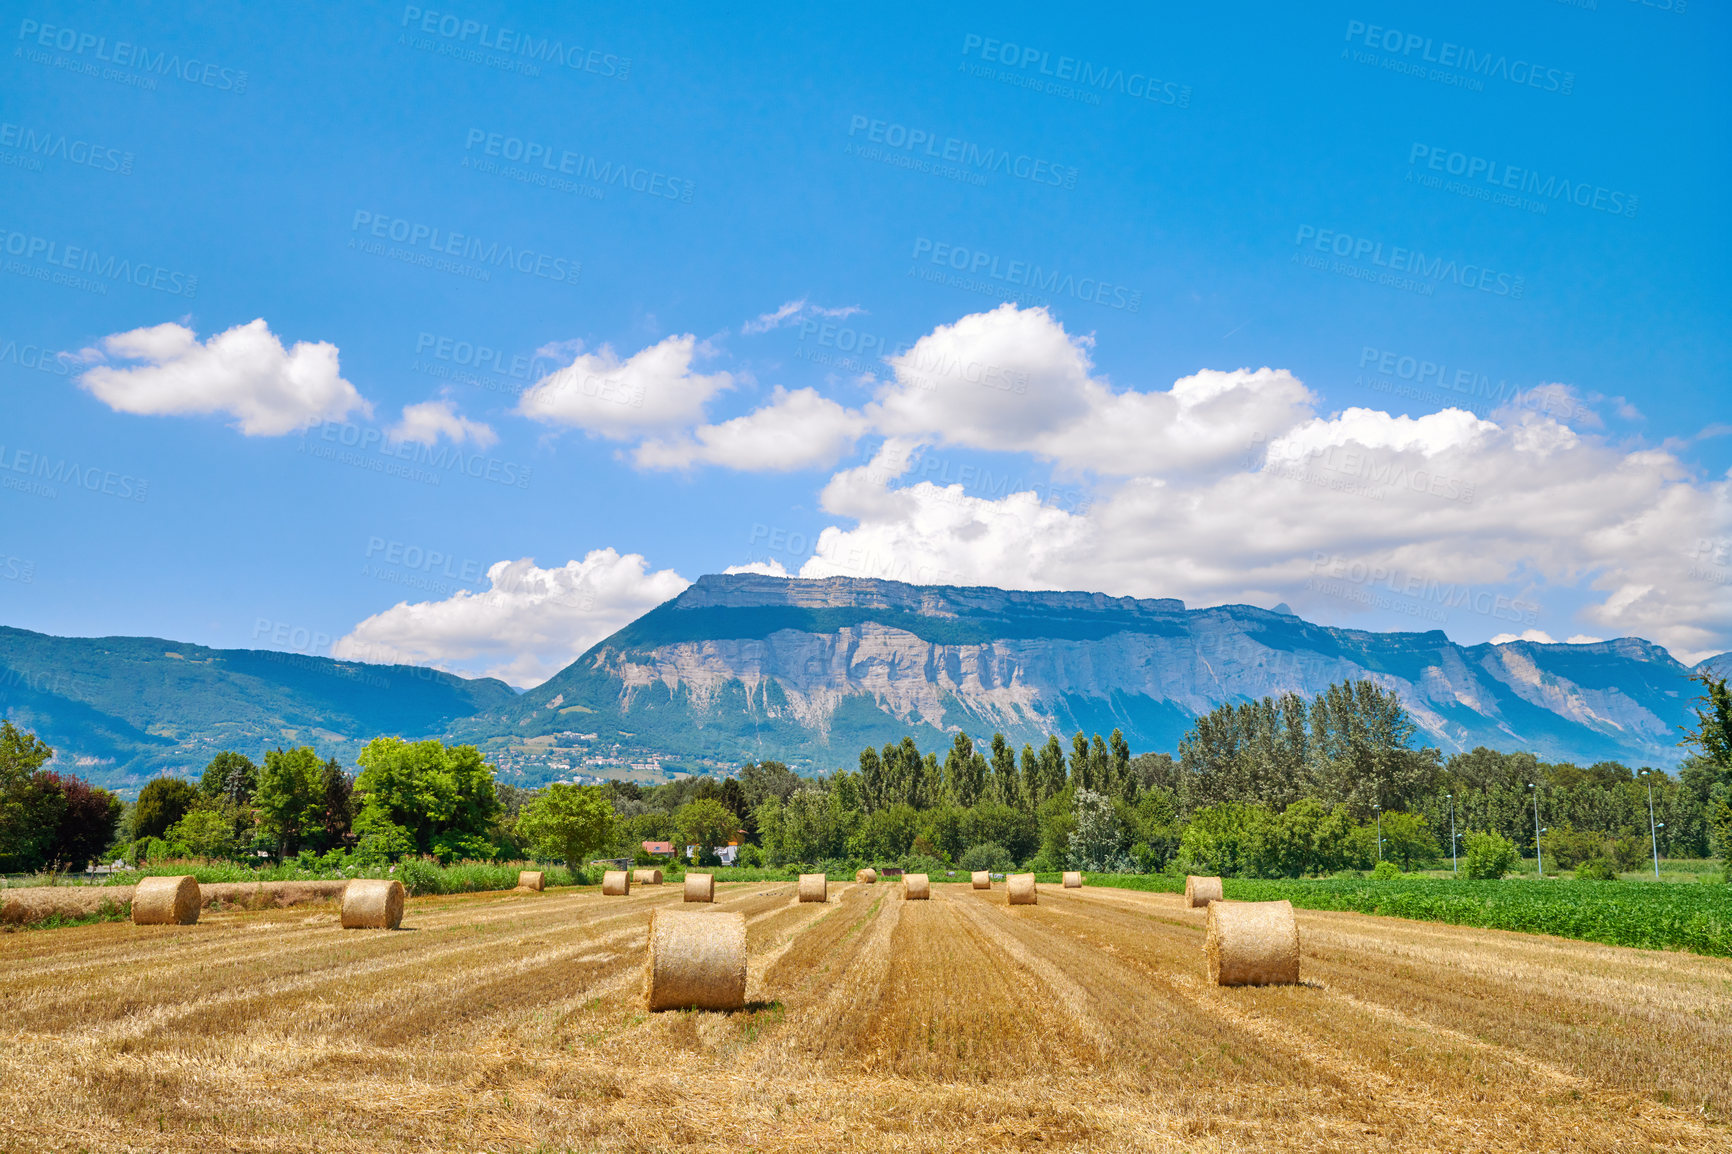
[{"xmin": 0, "ymin": 677, "xmax": 1732, "ymax": 877}]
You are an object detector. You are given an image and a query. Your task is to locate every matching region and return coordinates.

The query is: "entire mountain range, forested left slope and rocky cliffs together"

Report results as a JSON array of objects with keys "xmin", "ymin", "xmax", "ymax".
[{"xmin": 0, "ymin": 574, "xmax": 1732, "ymax": 794}]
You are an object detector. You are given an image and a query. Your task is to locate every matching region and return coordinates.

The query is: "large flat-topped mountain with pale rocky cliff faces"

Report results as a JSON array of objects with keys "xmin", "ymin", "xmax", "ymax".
[{"xmin": 520, "ymin": 575, "xmax": 1694, "ymax": 764}]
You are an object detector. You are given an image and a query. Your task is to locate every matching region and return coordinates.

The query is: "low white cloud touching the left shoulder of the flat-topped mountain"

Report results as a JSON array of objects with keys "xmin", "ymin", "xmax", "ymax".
[{"xmin": 333, "ymin": 549, "xmax": 691, "ymax": 686}]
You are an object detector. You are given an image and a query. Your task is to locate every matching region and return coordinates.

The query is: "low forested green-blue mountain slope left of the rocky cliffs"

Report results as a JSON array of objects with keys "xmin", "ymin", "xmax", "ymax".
[{"xmin": 0, "ymin": 627, "xmax": 516, "ymax": 795}]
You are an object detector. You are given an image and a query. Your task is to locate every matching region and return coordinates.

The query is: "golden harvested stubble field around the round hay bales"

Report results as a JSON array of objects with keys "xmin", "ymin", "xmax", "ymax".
[{"xmin": 0, "ymin": 882, "xmax": 1732, "ymax": 1152}]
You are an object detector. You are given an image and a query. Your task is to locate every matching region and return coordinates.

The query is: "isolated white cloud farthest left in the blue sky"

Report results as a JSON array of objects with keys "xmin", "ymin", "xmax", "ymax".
[{"xmin": 78, "ymin": 319, "xmax": 372, "ymax": 437}]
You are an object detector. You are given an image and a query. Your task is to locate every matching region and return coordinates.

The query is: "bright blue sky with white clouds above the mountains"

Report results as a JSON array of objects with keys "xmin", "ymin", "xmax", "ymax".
[{"xmin": 0, "ymin": 0, "xmax": 1732, "ymax": 684}]
